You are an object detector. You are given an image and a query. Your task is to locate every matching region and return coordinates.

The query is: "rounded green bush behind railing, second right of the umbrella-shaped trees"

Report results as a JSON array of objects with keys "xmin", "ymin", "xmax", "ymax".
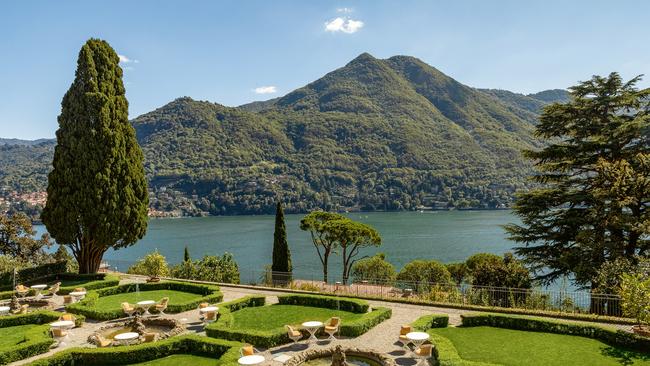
[{"xmin": 397, "ymin": 259, "xmax": 452, "ymax": 292}]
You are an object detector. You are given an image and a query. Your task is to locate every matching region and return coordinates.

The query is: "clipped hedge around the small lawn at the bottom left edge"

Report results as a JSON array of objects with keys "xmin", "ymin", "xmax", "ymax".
[{"xmin": 0, "ymin": 311, "xmax": 84, "ymax": 365}]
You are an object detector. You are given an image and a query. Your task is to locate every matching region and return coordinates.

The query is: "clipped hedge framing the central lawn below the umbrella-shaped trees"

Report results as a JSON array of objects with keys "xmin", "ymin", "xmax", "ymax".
[{"xmin": 205, "ymin": 295, "xmax": 392, "ymax": 348}]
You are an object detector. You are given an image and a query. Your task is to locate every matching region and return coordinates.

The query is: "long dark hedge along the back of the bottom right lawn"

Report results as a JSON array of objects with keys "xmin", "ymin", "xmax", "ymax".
[{"xmin": 461, "ymin": 313, "xmax": 650, "ymax": 353}]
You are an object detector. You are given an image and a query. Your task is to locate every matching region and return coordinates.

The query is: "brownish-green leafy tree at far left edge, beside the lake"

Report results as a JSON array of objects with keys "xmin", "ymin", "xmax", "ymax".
[{"xmin": 0, "ymin": 213, "xmax": 51, "ymax": 262}]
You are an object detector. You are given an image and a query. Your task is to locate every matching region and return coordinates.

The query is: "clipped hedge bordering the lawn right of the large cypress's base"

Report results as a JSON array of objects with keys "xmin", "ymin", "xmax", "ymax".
[{"xmin": 66, "ymin": 281, "xmax": 223, "ymax": 320}]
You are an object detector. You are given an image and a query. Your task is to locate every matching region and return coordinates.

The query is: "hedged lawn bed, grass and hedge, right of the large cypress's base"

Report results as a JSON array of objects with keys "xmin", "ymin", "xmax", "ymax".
[{"xmin": 67, "ymin": 281, "xmax": 223, "ymax": 320}]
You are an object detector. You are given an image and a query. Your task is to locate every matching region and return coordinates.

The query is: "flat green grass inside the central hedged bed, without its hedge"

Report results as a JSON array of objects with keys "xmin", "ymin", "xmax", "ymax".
[{"xmin": 232, "ymin": 305, "xmax": 365, "ymax": 330}]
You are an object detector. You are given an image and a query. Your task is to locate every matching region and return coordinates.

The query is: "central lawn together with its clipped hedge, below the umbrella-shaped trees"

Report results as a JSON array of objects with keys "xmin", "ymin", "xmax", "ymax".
[{"xmin": 206, "ymin": 295, "xmax": 391, "ymax": 347}]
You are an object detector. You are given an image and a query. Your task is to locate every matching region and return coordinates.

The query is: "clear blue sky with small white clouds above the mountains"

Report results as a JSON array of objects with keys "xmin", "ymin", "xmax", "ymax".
[{"xmin": 0, "ymin": 0, "xmax": 650, "ymax": 139}]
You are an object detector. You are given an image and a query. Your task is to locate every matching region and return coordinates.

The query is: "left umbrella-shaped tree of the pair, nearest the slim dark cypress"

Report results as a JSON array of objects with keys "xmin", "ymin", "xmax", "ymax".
[{"xmin": 300, "ymin": 211, "xmax": 346, "ymax": 282}]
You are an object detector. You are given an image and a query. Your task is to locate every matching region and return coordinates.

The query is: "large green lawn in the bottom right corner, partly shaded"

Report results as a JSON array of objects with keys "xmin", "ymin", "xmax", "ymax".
[{"xmin": 430, "ymin": 327, "xmax": 650, "ymax": 366}]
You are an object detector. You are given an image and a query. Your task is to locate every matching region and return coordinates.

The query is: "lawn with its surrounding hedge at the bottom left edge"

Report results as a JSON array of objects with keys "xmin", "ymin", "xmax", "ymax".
[{"xmin": 0, "ymin": 311, "xmax": 83, "ymax": 365}]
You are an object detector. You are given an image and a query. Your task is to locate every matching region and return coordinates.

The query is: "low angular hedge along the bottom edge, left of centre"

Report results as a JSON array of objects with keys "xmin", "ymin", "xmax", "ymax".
[{"xmin": 27, "ymin": 335, "xmax": 241, "ymax": 366}]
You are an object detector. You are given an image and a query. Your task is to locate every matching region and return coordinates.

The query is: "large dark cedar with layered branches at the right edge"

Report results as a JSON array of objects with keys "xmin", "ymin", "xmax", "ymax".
[{"xmin": 506, "ymin": 73, "xmax": 650, "ymax": 298}]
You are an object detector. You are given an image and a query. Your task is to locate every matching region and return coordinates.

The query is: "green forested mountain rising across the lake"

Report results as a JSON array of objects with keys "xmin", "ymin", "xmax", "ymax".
[{"xmin": 1, "ymin": 54, "xmax": 565, "ymax": 214}]
